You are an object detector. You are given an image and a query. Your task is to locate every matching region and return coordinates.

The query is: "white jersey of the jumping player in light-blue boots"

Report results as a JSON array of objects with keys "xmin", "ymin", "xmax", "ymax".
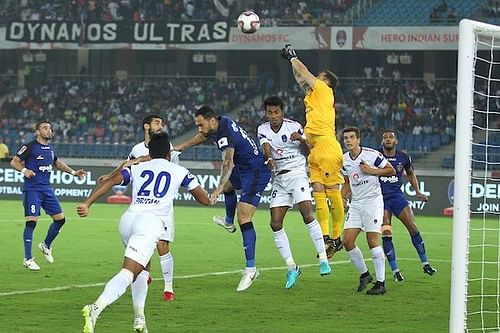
[{"xmin": 257, "ymin": 118, "xmax": 307, "ymax": 173}]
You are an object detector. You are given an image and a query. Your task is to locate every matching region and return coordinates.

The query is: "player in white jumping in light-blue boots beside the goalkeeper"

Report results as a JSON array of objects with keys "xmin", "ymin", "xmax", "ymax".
[{"xmin": 257, "ymin": 96, "xmax": 331, "ymax": 289}]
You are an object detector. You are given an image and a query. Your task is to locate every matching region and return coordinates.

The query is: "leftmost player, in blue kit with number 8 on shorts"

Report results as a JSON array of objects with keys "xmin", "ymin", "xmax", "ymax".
[{"xmin": 10, "ymin": 121, "xmax": 87, "ymax": 271}]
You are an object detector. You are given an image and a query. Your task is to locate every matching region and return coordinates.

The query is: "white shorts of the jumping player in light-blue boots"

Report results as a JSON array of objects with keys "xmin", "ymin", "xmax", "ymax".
[{"xmin": 269, "ymin": 168, "xmax": 312, "ymax": 208}]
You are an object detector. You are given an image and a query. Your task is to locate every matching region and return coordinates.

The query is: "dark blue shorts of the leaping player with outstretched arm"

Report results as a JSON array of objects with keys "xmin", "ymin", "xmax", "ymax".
[{"xmin": 229, "ymin": 165, "xmax": 271, "ymax": 207}]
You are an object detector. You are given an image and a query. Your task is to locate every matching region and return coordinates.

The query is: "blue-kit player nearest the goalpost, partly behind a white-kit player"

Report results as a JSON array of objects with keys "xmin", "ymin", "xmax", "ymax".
[{"xmin": 379, "ymin": 129, "xmax": 436, "ymax": 282}]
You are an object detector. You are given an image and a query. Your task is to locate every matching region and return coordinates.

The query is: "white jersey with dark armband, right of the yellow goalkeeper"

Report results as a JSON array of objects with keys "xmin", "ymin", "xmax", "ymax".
[{"xmin": 342, "ymin": 147, "xmax": 388, "ymax": 204}]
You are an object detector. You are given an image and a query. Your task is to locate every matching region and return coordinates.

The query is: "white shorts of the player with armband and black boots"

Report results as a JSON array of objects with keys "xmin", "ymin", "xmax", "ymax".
[{"xmin": 344, "ymin": 198, "xmax": 384, "ymax": 233}]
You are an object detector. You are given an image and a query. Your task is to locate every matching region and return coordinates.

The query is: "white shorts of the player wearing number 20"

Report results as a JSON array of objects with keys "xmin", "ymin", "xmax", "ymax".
[{"xmin": 119, "ymin": 211, "xmax": 163, "ymax": 267}]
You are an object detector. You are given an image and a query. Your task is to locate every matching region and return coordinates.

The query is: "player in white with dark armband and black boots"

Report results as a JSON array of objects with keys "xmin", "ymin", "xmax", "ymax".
[{"xmin": 342, "ymin": 127, "xmax": 396, "ymax": 295}]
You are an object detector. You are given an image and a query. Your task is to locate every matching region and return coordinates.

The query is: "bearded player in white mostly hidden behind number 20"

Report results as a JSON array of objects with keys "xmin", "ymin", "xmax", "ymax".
[{"xmin": 97, "ymin": 114, "xmax": 181, "ymax": 301}]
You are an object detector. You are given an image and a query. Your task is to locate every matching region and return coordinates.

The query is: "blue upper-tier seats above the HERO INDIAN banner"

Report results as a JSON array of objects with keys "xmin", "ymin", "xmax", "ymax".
[{"xmin": 354, "ymin": 0, "xmax": 488, "ymax": 26}]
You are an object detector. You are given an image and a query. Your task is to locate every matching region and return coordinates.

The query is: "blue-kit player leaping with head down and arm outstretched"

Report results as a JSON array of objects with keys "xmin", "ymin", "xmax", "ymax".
[{"xmin": 174, "ymin": 106, "xmax": 271, "ymax": 291}]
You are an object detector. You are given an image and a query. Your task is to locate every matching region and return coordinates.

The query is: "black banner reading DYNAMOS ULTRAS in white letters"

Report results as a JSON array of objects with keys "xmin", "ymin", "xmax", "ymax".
[{"xmin": 6, "ymin": 21, "xmax": 230, "ymax": 45}]
